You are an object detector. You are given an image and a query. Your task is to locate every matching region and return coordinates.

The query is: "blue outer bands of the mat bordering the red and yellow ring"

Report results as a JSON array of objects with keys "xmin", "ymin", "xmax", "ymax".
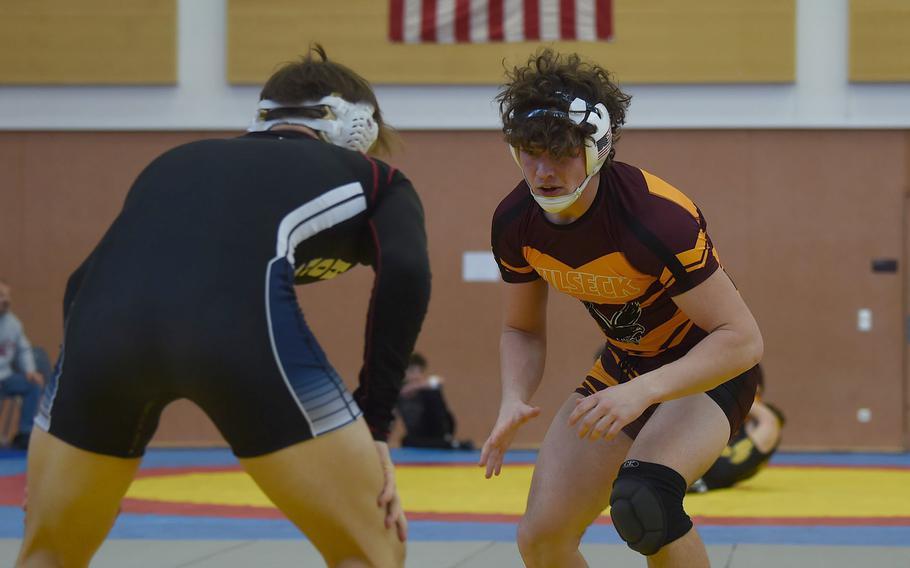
[{"xmin": 0, "ymin": 448, "xmax": 910, "ymax": 546}]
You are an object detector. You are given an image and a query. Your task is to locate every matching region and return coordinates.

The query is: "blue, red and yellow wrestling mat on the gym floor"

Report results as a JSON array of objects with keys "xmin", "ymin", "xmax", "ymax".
[{"xmin": 0, "ymin": 449, "xmax": 910, "ymax": 546}]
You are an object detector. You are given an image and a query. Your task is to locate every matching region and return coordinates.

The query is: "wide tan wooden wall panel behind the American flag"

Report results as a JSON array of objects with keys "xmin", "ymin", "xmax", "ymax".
[{"xmin": 228, "ymin": 0, "xmax": 796, "ymax": 84}]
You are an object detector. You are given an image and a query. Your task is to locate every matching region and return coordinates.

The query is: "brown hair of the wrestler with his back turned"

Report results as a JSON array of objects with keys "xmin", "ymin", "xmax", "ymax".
[{"xmin": 259, "ymin": 43, "xmax": 394, "ymax": 153}]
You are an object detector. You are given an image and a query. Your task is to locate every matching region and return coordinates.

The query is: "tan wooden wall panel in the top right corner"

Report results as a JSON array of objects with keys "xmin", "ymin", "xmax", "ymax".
[{"xmin": 849, "ymin": 0, "xmax": 910, "ymax": 82}]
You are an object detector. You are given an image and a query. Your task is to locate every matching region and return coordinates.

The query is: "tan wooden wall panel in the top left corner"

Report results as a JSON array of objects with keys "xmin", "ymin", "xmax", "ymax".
[{"xmin": 0, "ymin": 0, "xmax": 177, "ymax": 85}]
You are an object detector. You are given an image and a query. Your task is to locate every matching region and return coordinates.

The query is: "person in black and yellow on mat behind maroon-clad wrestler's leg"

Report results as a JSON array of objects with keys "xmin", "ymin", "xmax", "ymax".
[{"xmin": 689, "ymin": 367, "xmax": 785, "ymax": 493}]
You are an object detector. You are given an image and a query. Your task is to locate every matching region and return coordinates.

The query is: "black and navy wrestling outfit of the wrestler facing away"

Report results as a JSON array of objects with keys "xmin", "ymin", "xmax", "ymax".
[{"xmin": 36, "ymin": 131, "xmax": 430, "ymax": 457}]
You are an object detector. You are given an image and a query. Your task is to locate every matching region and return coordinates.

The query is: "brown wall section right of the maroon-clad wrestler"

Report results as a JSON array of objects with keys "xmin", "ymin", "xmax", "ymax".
[{"xmin": 622, "ymin": 131, "xmax": 907, "ymax": 449}]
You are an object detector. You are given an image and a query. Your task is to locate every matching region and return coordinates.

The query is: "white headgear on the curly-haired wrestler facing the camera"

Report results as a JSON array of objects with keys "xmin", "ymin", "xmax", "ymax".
[{"xmin": 510, "ymin": 92, "xmax": 613, "ymax": 213}]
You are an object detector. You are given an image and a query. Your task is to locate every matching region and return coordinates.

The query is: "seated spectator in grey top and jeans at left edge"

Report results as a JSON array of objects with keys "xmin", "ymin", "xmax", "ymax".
[{"xmin": 0, "ymin": 280, "xmax": 44, "ymax": 450}]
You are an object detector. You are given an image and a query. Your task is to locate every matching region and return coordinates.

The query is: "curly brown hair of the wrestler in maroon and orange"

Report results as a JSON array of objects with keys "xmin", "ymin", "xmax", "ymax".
[{"xmin": 496, "ymin": 48, "xmax": 632, "ymax": 165}]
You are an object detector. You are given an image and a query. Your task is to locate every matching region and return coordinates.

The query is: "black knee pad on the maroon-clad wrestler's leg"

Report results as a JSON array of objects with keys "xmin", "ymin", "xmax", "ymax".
[{"xmin": 610, "ymin": 460, "xmax": 692, "ymax": 556}]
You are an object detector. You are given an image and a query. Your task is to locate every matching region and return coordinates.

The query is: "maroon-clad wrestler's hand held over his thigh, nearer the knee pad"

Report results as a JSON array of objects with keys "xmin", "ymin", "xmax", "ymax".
[{"xmin": 569, "ymin": 380, "xmax": 653, "ymax": 440}]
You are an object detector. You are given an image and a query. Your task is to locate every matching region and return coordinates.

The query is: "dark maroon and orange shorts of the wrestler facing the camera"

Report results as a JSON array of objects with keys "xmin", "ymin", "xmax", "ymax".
[{"xmin": 575, "ymin": 348, "xmax": 761, "ymax": 440}]
